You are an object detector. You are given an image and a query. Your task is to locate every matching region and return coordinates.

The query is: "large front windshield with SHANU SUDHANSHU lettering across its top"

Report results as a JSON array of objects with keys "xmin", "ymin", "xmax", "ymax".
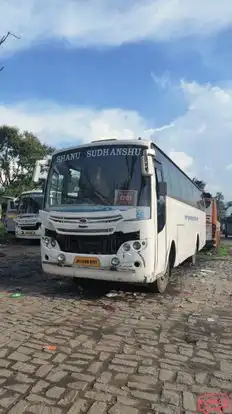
[{"xmin": 45, "ymin": 145, "xmax": 151, "ymax": 209}]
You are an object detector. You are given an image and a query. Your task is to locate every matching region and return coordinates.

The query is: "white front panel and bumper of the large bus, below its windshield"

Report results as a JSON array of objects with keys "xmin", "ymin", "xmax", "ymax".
[{"xmin": 41, "ymin": 209, "xmax": 154, "ymax": 282}]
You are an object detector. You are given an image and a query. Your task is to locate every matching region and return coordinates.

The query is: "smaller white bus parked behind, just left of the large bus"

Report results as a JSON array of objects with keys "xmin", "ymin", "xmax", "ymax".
[{"xmin": 15, "ymin": 190, "xmax": 43, "ymax": 240}]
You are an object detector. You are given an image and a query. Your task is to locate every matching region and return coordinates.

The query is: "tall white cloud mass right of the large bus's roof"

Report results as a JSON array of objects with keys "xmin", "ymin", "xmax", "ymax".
[{"xmin": 157, "ymin": 81, "xmax": 232, "ymax": 199}]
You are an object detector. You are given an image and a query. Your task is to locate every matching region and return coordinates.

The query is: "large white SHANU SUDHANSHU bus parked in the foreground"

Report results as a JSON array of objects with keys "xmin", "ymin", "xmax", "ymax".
[{"xmin": 40, "ymin": 139, "xmax": 206, "ymax": 293}]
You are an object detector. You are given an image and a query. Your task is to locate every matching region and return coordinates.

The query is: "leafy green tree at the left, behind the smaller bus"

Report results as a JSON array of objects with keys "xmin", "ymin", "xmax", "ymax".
[{"xmin": 0, "ymin": 125, "xmax": 54, "ymax": 195}]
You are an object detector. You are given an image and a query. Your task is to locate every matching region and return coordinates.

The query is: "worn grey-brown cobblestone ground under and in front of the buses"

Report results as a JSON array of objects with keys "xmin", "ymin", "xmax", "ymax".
[{"xmin": 0, "ymin": 244, "xmax": 232, "ymax": 414}]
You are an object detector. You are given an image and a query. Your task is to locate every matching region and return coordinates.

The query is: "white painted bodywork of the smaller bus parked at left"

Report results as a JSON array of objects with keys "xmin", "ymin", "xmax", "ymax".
[{"xmin": 15, "ymin": 190, "xmax": 42, "ymax": 240}]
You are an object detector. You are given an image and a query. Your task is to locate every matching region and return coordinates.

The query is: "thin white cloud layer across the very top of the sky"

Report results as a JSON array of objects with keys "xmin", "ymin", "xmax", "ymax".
[{"xmin": 0, "ymin": 0, "xmax": 232, "ymax": 50}]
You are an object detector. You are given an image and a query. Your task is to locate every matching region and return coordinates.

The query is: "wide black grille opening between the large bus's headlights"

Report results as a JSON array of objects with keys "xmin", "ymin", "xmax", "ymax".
[{"xmin": 45, "ymin": 229, "xmax": 140, "ymax": 255}]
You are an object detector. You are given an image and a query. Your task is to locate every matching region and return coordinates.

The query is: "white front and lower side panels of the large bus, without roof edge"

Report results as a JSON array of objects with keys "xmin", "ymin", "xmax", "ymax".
[{"xmin": 41, "ymin": 198, "xmax": 205, "ymax": 283}]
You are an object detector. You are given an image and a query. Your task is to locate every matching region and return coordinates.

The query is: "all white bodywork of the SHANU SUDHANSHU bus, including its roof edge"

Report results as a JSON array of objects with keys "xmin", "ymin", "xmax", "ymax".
[{"xmin": 40, "ymin": 140, "xmax": 206, "ymax": 283}]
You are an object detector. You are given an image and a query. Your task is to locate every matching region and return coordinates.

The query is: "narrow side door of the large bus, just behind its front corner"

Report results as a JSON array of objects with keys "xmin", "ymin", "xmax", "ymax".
[{"xmin": 155, "ymin": 161, "xmax": 167, "ymax": 274}]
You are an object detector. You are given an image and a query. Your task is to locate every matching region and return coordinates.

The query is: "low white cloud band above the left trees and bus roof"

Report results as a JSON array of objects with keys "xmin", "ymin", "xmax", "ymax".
[{"xmin": 0, "ymin": 102, "xmax": 154, "ymax": 146}]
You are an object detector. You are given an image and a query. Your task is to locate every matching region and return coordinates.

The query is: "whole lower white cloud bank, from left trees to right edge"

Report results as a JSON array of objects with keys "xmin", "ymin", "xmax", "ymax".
[{"xmin": 0, "ymin": 81, "xmax": 232, "ymax": 200}]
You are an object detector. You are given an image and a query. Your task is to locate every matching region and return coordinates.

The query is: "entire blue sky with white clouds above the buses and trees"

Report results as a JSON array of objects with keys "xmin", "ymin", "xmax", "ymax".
[{"xmin": 0, "ymin": 0, "xmax": 232, "ymax": 200}]
